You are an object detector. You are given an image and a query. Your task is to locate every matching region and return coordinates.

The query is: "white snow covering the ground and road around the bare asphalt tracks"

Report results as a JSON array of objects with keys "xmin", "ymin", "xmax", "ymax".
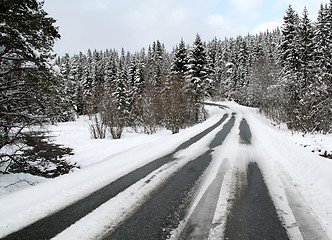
[{"xmin": 0, "ymin": 103, "xmax": 332, "ymax": 239}]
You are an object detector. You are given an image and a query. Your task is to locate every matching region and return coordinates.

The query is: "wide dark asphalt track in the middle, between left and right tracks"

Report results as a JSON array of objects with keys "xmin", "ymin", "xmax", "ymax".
[{"xmin": 105, "ymin": 115, "xmax": 235, "ymax": 240}]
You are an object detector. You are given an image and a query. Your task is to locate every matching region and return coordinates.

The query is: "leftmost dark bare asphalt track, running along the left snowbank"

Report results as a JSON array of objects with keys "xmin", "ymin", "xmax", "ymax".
[{"xmin": 1, "ymin": 114, "xmax": 228, "ymax": 240}]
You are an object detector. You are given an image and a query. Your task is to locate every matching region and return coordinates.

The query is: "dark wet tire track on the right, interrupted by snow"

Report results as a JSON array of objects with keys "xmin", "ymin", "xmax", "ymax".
[{"xmin": 224, "ymin": 119, "xmax": 289, "ymax": 240}]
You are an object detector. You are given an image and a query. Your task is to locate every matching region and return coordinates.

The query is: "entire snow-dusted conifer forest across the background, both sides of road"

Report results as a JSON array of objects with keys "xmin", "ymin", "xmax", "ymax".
[{"xmin": 57, "ymin": 4, "xmax": 332, "ymax": 138}]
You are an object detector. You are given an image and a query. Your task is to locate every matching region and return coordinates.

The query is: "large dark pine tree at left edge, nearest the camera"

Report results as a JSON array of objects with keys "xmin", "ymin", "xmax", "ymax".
[{"xmin": 0, "ymin": 0, "xmax": 60, "ymax": 167}]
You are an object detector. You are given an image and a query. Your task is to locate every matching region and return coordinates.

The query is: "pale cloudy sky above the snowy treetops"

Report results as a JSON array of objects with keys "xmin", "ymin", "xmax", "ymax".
[{"xmin": 44, "ymin": 0, "xmax": 328, "ymax": 56}]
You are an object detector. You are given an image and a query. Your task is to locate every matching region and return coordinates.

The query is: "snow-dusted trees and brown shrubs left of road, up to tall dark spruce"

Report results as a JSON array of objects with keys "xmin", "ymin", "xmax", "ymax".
[{"xmin": 57, "ymin": 35, "xmax": 211, "ymax": 138}]
